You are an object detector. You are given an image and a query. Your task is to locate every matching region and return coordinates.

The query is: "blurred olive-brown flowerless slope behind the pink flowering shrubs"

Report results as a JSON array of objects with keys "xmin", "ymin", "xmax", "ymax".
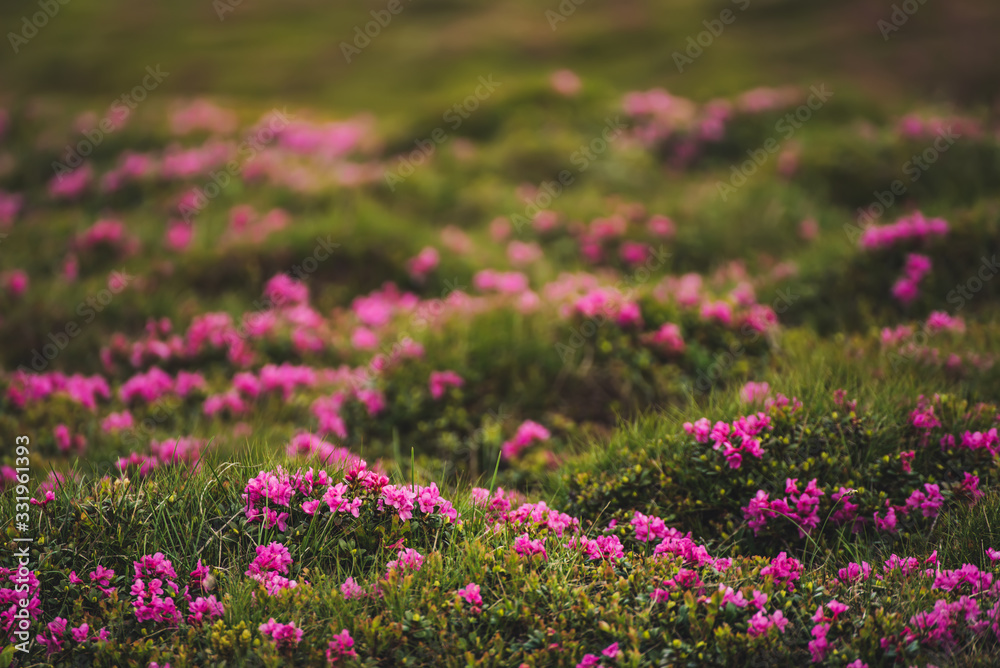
[{"xmin": 0, "ymin": 0, "xmax": 1000, "ymax": 115}]
